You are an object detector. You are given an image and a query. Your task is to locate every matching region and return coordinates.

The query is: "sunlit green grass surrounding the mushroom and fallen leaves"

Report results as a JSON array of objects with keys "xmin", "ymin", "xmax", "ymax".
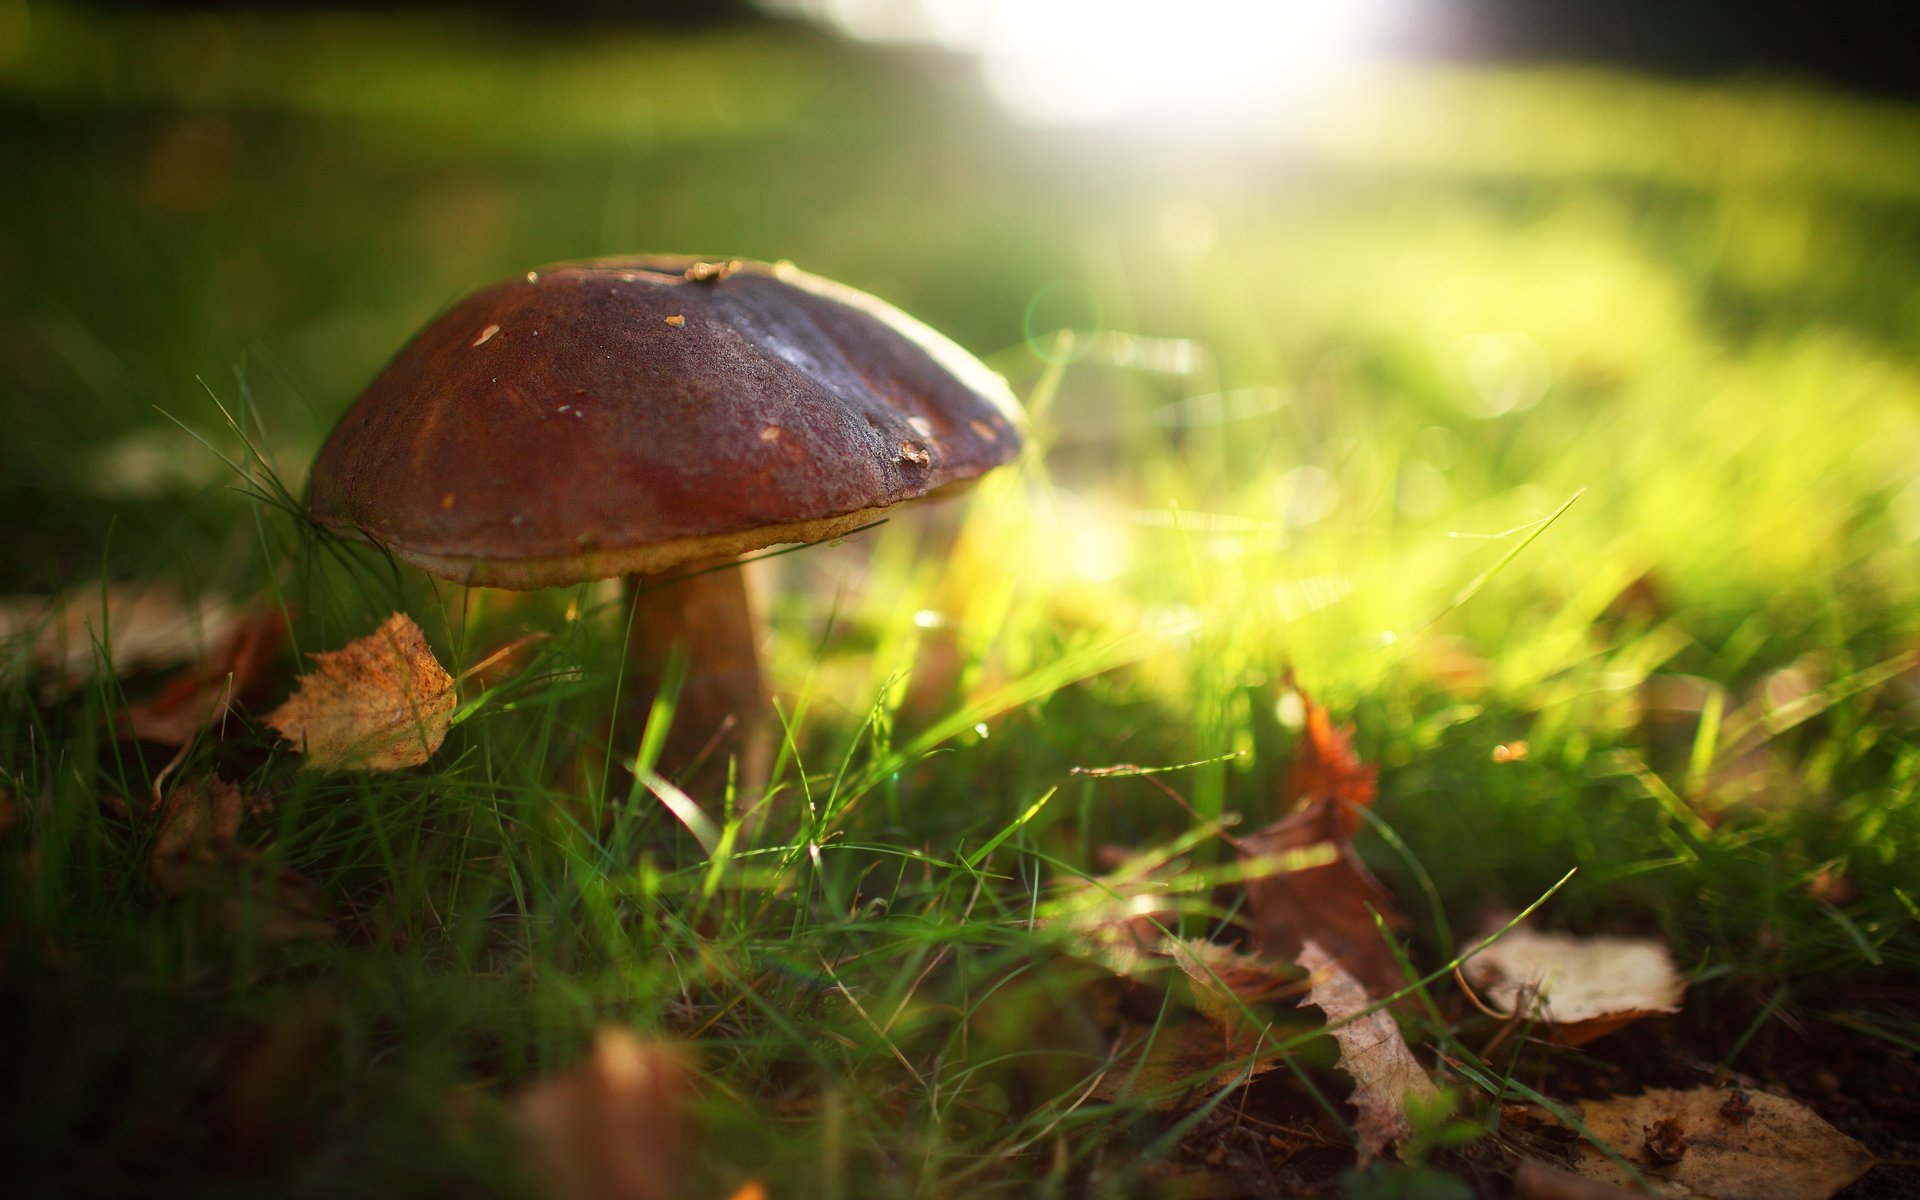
[{"xmin": 0, "ymin": 4, "xmax": 1920, "ymax": 1196}]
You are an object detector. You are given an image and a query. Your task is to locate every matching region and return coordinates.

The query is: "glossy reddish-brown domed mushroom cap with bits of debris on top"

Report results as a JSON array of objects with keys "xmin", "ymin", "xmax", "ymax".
[{"xmin": 309, "ymin": 255, "xmax": 1021, "ymax": 588}]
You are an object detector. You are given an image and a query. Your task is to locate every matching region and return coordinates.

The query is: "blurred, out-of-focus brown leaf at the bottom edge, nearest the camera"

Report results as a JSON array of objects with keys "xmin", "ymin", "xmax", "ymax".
[{"xmin": 518, "ymin": 1029, "xmax": 687, "ymax": 1200}]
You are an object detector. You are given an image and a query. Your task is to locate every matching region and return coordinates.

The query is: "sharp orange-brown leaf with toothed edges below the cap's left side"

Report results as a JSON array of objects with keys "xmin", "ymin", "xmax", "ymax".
[{"xmin": 267, "ymin": 612, "xmax": 457, "ymax": 770}]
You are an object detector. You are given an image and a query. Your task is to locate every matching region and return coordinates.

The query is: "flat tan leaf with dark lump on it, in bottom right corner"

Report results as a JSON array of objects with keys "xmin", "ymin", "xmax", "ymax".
[{"xmin": 1574, "ymin": 1087, "xmax": 1874, "ymax": 1200}]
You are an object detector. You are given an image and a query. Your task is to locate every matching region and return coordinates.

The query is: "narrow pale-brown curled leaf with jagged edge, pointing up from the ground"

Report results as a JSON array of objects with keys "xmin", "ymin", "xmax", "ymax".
[{"xmin": 1298, "ymin": 939, "xmax": 1438, "ymax": 1162}]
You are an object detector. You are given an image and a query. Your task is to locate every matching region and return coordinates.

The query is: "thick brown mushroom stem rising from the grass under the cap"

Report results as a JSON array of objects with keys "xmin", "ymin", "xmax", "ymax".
[{"xmin": 626, "ymin": 561, "xmax": 772, "ymax": 806}]
